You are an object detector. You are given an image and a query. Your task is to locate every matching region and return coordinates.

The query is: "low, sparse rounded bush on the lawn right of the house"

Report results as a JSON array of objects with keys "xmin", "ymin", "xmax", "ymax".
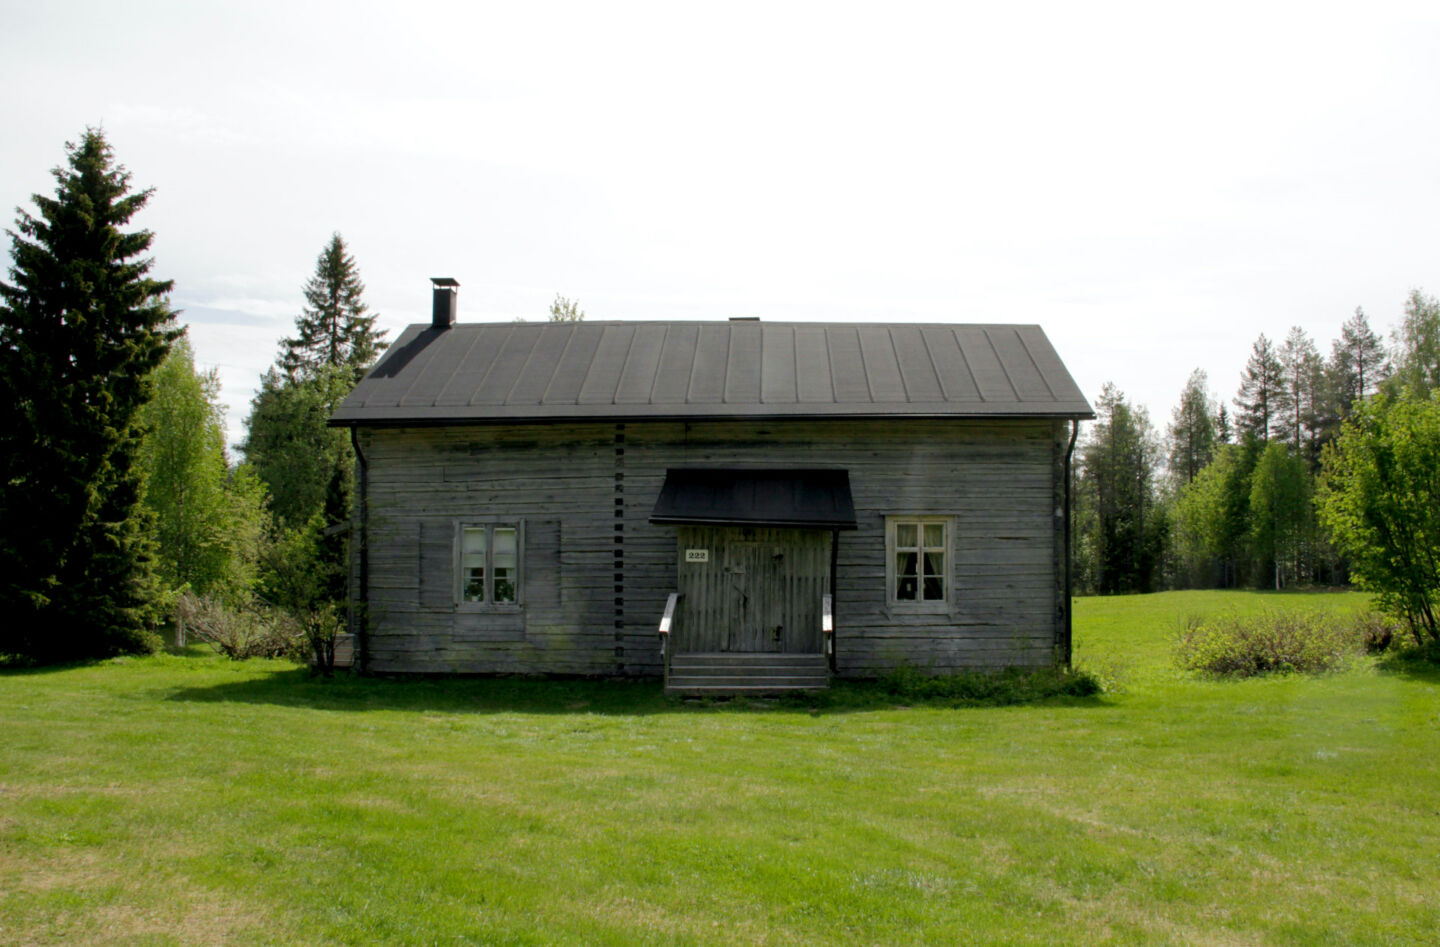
[{"xmin": 1175, "ymin": 612, "xmax": 1368, "ymax": 678}]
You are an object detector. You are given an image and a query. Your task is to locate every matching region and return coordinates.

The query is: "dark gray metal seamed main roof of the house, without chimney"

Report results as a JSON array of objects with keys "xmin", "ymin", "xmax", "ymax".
[{"xmin": 330, "ymin": 321, "xmax": 1093, "ymax": 425}]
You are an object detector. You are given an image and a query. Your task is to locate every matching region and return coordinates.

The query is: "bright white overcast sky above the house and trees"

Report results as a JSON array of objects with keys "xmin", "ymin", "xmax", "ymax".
[{"xmin": 0, "ymin": 0, "xmax": 1440, "ymax": 442}]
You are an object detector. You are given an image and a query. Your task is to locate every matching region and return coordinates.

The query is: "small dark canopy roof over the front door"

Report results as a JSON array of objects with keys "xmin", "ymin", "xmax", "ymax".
[{"xmin": 649, "ymin": 468, "xmax": 855, "ymax": 530}]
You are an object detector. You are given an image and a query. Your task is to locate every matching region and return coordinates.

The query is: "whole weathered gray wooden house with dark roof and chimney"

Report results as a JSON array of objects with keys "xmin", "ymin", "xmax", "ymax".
[{"xmin": 331, "ymin": 279, "xmax": 1093, "ymax": 692}]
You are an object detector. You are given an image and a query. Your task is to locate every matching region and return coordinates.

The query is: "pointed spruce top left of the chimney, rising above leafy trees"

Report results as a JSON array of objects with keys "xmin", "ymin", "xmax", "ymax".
[{"xmin": 279, "ymin": 233, "xmax": 384, "ymax": 380}]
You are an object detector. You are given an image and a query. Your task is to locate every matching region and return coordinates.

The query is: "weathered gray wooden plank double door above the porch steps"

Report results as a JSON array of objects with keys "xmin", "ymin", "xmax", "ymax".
[{"xmin": 674, "ymin": 527, "xmax": 831, "ymax": 653}]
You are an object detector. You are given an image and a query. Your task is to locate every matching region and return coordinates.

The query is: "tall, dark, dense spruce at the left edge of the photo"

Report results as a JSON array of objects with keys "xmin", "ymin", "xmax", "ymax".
[{"xmin": 0, "ymin": 130, "xmax": 176, "ymax": 662}]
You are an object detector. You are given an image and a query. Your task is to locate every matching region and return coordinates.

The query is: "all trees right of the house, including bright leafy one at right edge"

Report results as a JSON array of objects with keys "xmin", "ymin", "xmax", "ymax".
[{"xmin": 1071, "ymin": 299, "xmax": 1440, "ymax": 638}]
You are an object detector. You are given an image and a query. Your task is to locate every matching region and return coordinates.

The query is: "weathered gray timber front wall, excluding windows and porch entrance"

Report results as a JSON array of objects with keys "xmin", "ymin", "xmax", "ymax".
[{"xmin": 360, "ymin": 419, "xmax": 1066, "ymax": 676}]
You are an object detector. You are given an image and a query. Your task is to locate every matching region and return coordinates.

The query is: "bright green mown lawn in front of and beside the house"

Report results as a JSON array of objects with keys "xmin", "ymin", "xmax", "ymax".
[{"xmin": 0, "ymin": 593, "xmax": 1440, "ymax": 944}]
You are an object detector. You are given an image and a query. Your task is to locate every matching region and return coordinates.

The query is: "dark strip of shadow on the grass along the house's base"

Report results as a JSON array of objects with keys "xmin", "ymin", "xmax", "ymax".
[{"xmin": 166, "ymin": 668, "xmax": 1109, "ymax": 717}]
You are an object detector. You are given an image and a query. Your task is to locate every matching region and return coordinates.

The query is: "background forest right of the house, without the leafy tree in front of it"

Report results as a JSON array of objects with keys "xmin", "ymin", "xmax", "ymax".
[{"xmin": 1071, "ymin": 289, "xmax": 1440, "ymax": 604}]
